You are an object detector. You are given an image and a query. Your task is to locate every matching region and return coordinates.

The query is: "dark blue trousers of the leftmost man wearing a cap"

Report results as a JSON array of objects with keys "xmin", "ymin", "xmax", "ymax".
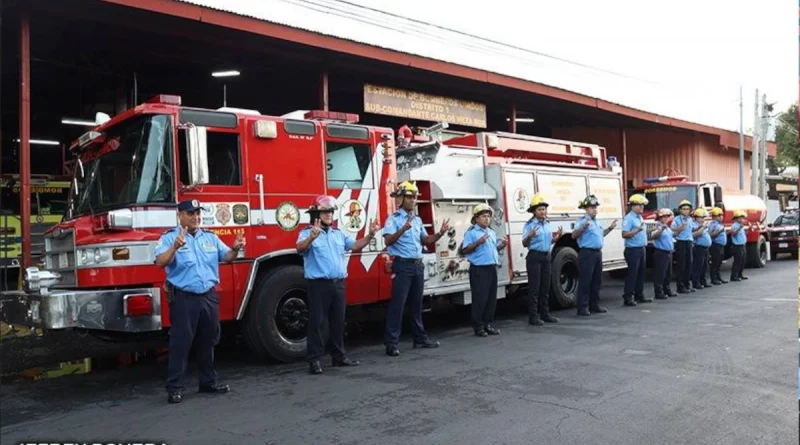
[{"xmin": 167, "ymin": 288, "xmax": 220, "ymax": 392}]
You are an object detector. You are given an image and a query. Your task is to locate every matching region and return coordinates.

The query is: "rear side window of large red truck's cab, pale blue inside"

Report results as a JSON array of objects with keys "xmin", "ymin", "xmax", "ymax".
[{"xmin": 326, "ymin": 142, "xmax": 373, "ymax": 190}]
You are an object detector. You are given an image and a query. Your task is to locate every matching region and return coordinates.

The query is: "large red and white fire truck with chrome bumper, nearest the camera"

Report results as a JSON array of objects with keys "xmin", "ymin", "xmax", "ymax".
[{"xmin": 2, "ymin": 95, "xmax": 625, "ymax": 361}]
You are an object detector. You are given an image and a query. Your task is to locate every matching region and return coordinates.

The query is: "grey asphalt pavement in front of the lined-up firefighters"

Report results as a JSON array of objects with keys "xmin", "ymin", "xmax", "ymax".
[{"xmin": 0, "ymin": 258, "xmax": 798, "ymax": 445}]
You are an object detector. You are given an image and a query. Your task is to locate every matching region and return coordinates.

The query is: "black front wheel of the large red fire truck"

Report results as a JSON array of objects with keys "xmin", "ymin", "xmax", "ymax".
[{"xmin": 243, "ymin": 265, "xmax": 320, "ymax": 363}]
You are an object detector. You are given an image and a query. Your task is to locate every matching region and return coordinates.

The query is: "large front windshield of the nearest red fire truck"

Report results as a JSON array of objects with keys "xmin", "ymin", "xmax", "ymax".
[{"xmin": 70, "ymin": 114, "xmax": 175, "ymax": 218}]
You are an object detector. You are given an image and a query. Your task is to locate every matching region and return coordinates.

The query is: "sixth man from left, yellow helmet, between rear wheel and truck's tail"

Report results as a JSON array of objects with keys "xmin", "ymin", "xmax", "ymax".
[{"xmin": 572, "ymin": 195, "xmax": 617, "ymax": 316}]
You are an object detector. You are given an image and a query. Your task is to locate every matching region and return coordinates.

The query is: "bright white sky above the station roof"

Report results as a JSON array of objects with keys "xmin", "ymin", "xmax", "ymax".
[{"xmin": 188, "ymin": 0, "xmax": 800, "ymax": 132}]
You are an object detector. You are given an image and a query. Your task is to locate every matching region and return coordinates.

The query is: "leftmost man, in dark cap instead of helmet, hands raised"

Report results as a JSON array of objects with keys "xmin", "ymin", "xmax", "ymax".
[{"xmin": 155, "ymin": 199, "xmax": 245, "ymax": 403}]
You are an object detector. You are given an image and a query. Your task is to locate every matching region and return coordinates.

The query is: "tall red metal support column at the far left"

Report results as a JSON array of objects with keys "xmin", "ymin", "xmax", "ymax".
[{"xmin": 19, "ymin": 5, "xmax": 31, "ymax": 268}]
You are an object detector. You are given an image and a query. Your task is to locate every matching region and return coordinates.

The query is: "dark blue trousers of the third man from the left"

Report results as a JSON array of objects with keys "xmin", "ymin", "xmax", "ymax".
[{"xmin": 384, "ymin": 258, "xmax": 428, "ymax": 346}]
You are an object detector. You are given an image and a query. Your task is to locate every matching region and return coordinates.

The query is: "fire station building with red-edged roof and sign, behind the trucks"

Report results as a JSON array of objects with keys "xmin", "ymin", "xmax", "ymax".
[{"xmin": 0, "ymin": 0, "xmax": 776, "ymax": 194}]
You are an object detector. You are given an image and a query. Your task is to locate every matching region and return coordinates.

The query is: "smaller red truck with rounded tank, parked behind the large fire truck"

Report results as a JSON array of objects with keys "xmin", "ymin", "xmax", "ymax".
[{"xmin": 631, "ymin": 170, "xmax": 769, "ymax": 268}]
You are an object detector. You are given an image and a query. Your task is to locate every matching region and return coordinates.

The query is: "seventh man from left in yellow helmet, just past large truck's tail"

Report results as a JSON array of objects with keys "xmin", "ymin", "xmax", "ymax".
[{"xmin": 622, "ymin": 194, "xmax": 653, "ymax": 306}]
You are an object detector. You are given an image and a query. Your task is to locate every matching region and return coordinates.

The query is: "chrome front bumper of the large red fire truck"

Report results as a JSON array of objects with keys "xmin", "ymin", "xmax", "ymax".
[{"xmin": 0, "ymin": 288, "xmax": 162, "ymax": 333}]
